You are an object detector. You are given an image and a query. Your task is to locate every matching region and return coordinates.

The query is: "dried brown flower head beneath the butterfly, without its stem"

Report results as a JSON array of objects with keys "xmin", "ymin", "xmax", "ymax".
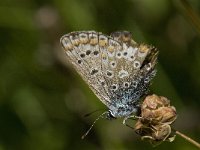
[{"xmin": 135, "ymin": 94, "xmax": 177, "ymax": 144}]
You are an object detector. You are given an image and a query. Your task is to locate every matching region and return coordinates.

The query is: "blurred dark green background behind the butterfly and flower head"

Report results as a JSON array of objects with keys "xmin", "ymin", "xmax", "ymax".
[{"xmin": 0, "ymin": 0, "xmax": 200, "ymax": 150}]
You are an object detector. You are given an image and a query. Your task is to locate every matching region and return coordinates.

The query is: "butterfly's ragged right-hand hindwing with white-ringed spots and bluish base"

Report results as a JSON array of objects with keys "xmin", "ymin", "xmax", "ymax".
[{"xmin": 93, "ymin": 31, "xmax": 158, "ymax": 117}]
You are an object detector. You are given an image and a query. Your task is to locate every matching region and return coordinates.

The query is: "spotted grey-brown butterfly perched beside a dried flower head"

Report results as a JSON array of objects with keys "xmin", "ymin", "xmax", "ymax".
[{"xmin": 60, "ymin": 31, "xmax": 158, "ymax": 137}]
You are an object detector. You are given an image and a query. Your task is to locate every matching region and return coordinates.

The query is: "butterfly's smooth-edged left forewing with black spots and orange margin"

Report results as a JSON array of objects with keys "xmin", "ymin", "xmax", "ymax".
[{"xmin": 60, "ymin": 31, "xmax": 114, "ymax": 106}]
